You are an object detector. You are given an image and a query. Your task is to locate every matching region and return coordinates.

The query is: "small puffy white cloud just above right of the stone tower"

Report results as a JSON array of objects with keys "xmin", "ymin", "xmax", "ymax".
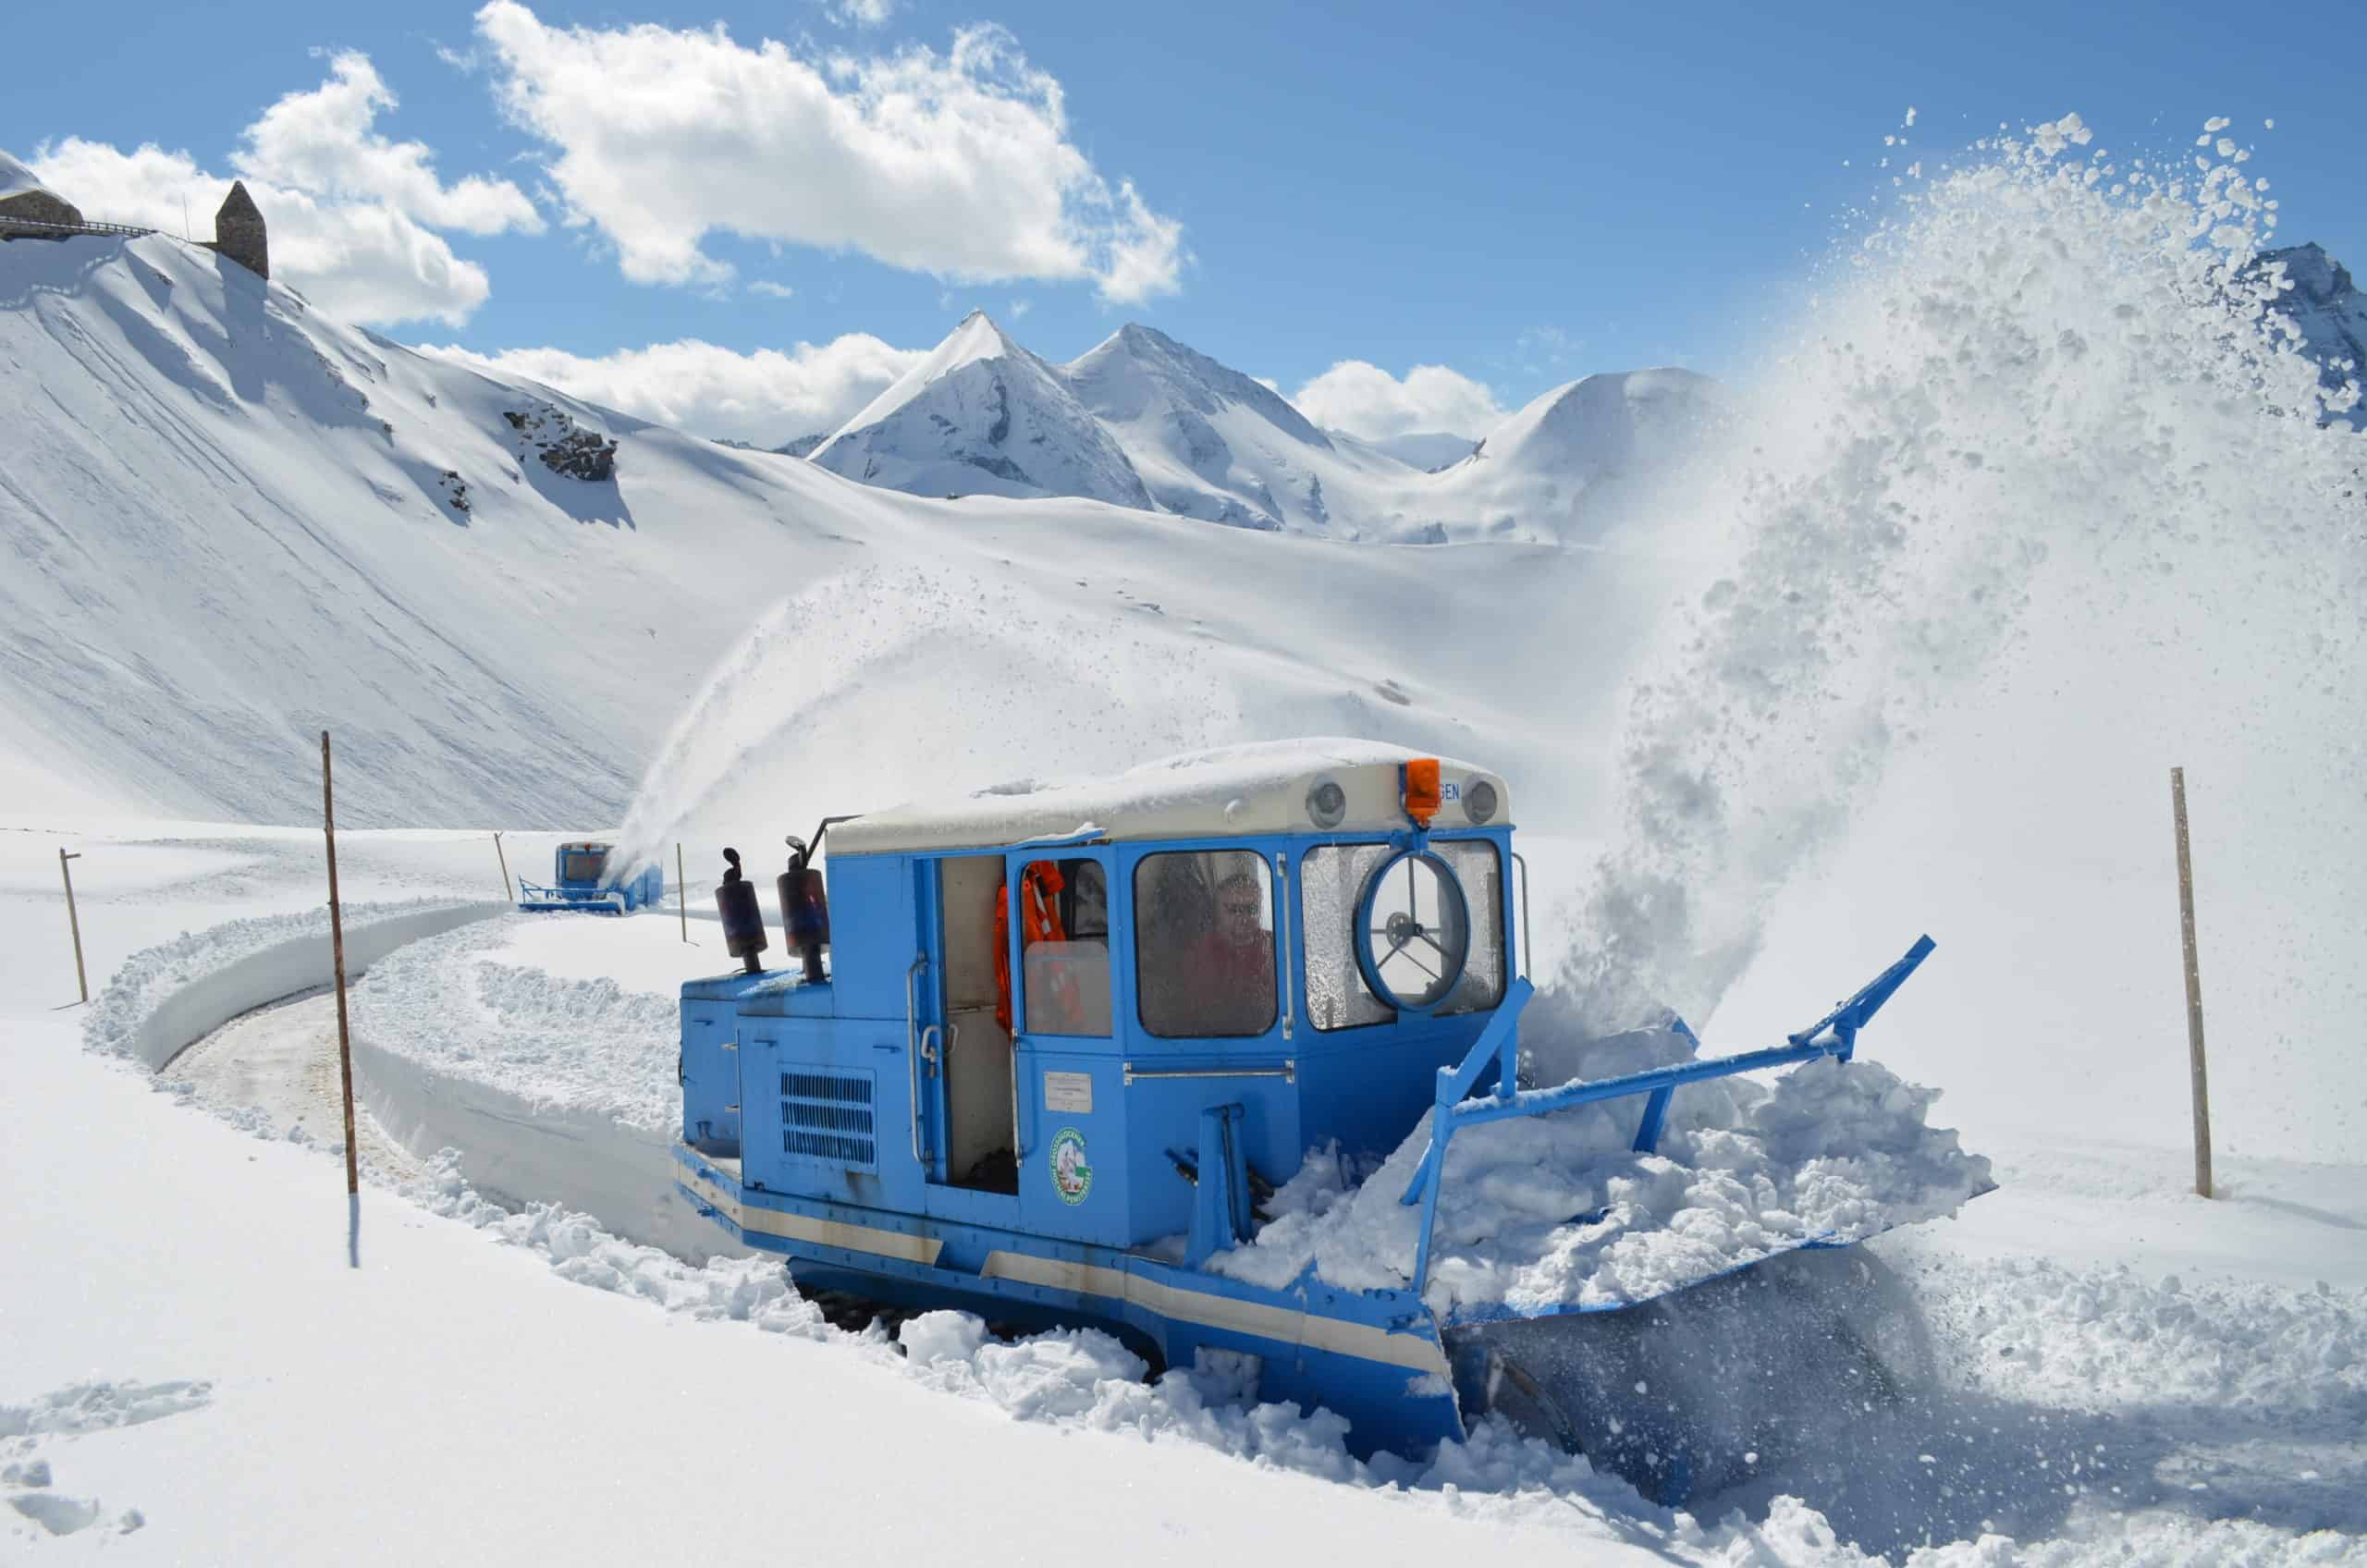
[{"xmin": 229, "ymin": 50, "xmax": 542, "ymax": 235}]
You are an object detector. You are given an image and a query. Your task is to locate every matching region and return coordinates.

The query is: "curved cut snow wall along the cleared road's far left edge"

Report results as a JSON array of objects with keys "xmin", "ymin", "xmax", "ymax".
[{"xmin": 106, "ymin": 902, "xmax": 509, "ymax": 1071}]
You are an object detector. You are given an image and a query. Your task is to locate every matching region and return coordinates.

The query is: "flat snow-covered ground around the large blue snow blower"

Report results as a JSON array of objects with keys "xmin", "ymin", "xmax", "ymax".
[{"xmin": 0, "ymin": 825, "xmax": 2367, "ymax": 1563}]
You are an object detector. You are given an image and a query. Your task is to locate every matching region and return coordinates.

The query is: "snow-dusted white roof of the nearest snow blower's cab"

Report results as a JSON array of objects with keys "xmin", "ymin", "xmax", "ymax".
[{"xmin": 831, "ymin": 739, "xmax": 1513, "ymax": 855}]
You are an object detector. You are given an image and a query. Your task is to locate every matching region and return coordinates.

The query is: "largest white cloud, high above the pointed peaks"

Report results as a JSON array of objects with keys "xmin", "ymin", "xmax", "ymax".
[{"xmin": 476, "ymin": 0, "xmax": 1188, "ymax": 303}]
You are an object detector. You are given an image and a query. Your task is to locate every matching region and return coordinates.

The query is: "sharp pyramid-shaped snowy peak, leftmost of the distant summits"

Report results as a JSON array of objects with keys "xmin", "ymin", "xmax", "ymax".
[{"xmin": 810, "ymin": 311, "xmax": 1150, "ymax": 509}]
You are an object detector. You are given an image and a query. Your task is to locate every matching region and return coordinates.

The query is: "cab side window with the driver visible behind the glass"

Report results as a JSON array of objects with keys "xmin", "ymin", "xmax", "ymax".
[{"xmin": 1134, "ymin": 851, "xmax": 1281, "ymax": 1040}]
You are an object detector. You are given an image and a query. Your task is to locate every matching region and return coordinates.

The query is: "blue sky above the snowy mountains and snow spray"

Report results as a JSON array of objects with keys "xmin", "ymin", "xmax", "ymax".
[{"xmin": 0, "ymin": 0, "xmax": 2367, "ymax": 438}]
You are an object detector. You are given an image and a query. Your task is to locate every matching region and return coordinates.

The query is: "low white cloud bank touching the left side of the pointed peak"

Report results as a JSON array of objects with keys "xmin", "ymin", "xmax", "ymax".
[{"xmin": 423, "ymin": 332, "xmax": 928, "ymax": 447}]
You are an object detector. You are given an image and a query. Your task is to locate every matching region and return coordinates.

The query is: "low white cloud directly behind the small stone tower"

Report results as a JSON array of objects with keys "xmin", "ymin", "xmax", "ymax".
[{"xmin": 33, "ymin": 138, "xmax": 492, "ymax": 327}]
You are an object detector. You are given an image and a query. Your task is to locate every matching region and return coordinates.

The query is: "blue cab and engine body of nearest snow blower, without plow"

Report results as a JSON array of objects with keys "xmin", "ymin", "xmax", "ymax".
[{"xmin": 681, "ymin": 741, "xmax": 1520, "ymax": 1268}]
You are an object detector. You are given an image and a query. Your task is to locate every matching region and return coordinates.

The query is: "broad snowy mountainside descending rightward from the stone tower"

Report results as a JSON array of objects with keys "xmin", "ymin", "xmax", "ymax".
[{"xmin": 0, "ymin": 235, "xmax": 1652, "ymax": 827}]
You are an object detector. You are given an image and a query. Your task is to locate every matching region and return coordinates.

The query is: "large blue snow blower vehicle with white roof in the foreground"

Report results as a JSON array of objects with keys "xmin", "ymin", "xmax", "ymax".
[{"xmin": 677, "ymin": 741, "xmax": 1932, "ymax": 1500}]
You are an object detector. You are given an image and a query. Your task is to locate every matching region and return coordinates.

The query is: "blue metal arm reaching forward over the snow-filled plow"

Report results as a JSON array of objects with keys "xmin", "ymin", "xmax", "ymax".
[{"xmin": 1399, "ymin": 936, "xmax": 1934, "ymax": 1295}]
